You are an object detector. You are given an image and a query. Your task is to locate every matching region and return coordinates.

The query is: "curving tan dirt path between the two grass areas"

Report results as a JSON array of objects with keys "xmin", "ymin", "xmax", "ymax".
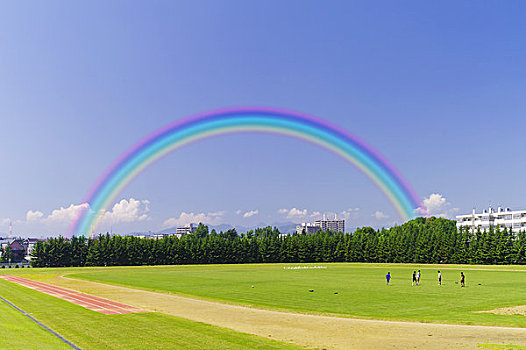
[{"xmin": 42, "ymin": 277, "xmax": 526, "ymax": 349}]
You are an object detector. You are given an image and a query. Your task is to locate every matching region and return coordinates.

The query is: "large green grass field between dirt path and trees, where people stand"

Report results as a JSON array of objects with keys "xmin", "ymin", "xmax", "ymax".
[{"xmin": 63, "ymin": 263, "xmax": 526, "ymax": 327}]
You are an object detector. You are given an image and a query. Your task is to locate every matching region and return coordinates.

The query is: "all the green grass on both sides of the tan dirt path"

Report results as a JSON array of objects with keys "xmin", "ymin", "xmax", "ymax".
[{"xmin": 0, "ymin": 264, "xmax": 526, "ymax": 349}]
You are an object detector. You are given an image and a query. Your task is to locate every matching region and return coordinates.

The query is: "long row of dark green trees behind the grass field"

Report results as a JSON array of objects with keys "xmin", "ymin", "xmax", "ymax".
[{"xmin": 32, "ymin": 217, "xmax": 526, "ymax": 267}]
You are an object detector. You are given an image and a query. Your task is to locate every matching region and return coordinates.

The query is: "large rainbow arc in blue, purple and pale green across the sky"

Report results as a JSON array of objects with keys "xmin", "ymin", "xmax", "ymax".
[{"xmin": 68, "ymin": 107, "xmax": 423, "ymax": 236}]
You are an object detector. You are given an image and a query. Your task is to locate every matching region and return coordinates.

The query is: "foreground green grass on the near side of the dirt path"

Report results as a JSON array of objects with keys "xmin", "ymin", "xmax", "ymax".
[{"xmin": 0, "ymin": 278, "xmax": 306, "ymax": 350}]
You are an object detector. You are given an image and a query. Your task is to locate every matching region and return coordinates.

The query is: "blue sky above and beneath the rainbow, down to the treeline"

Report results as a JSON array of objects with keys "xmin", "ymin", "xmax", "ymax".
[{"xmin": 0, "ymin": 1, "xmax": 526, "ymax": 236}]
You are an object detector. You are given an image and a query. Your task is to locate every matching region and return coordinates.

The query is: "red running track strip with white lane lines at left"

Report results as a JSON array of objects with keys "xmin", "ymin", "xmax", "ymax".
[{"xmin": 0, "ymin": 275, "xmax": 149, "ymax": 315}]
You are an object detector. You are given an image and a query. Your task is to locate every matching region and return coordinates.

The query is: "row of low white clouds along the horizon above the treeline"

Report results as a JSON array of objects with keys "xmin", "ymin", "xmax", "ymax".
[{"xmin": 5, "ymin": 193, "xmax": 458, "ymax": 234}]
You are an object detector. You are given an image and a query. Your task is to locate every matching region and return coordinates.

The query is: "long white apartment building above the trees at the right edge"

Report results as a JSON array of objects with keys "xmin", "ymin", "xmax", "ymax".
[{"xmin": 457, "ymin": 207, "xmax": 526, "ymax": 233}]
